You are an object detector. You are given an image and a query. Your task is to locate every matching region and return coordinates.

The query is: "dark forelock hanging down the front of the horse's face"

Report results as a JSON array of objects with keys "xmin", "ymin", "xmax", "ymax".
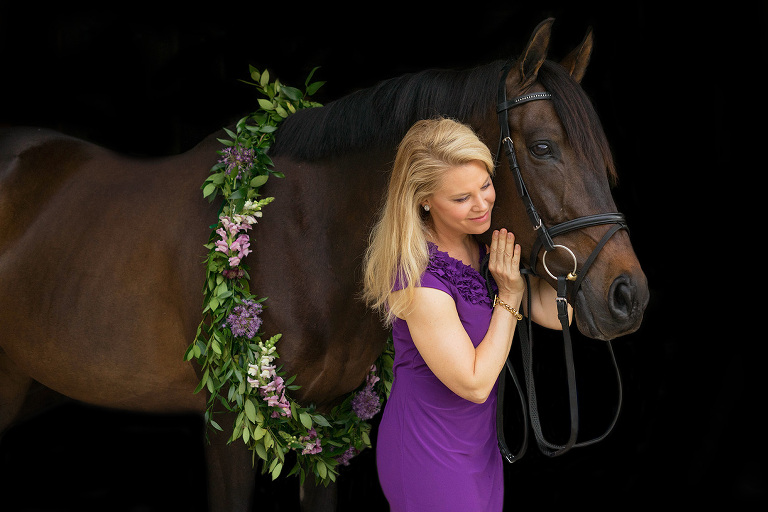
[{"xmin": 538, "ymin": 61, "xmax": 617, "ymax": 183}]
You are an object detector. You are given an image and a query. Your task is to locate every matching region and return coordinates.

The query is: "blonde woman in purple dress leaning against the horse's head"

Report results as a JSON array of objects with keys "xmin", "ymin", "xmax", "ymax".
[{"xmin": 364, "ymin": 119, "xmax": 560, "ymax": 512}]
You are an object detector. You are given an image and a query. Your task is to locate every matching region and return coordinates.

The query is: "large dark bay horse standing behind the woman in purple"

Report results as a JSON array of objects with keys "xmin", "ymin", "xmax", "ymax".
[{"xmin": 0, "ymin": 19, "xmax": 649, "ymax": 512}]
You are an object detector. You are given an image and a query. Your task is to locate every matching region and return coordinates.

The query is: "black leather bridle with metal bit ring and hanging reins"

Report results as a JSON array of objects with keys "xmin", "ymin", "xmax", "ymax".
[{"xmin": 484, "ymin": 62, "xmax": 628, "ymax": 462}]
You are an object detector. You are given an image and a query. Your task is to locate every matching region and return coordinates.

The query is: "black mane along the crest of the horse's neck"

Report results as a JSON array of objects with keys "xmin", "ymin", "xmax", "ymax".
[{"xmin": 270, "ymin": 63, "xmax": 501, "ymax": 160}]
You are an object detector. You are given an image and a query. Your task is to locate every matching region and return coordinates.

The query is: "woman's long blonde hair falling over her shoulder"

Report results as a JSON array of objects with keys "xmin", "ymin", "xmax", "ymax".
[{"xmin": 362, "ymin": 118, "xmax": 494, "ymax": 325}]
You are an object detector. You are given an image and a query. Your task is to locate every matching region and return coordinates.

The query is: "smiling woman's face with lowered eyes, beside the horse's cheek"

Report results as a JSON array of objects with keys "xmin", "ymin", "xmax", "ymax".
[{"xmin": 425, "ymin": 160, "xmax": 496, "ymax": 236}]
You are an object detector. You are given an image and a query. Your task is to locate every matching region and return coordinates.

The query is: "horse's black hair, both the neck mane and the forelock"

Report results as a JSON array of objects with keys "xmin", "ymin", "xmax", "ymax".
[{"xmin": 270, "ymin": 61, "xmax": 616, "ymax": 183}]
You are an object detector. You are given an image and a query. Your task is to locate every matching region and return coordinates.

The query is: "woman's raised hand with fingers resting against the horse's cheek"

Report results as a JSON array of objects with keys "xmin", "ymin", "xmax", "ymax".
[{"xmin": 488, "ymin": 228, "xmax": 525, "ymax": 308}]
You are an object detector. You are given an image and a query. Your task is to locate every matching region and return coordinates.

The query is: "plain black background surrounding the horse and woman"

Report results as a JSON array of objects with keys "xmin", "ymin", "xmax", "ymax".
[{"xmin": 0, "ymin": 0, "xmax": 768, "ymax": 511}]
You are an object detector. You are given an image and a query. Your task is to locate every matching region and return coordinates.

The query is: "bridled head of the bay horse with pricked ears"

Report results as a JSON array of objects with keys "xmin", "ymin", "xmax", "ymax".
[{"xmin": 486, "ymin": 19, "xmax": 649, "ymax": 340}]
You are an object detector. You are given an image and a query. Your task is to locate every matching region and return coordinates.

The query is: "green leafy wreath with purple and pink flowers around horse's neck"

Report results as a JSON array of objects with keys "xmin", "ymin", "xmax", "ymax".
[{"xmin": 184, "ymin": 67, "xmax": 393, "ymax": 485}]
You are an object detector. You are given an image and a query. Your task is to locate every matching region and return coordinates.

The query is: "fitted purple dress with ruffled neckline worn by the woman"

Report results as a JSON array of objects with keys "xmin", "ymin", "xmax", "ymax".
[{"xmin": 376, "ymin": 244, "xmax": 504, "ymax": 512}]
